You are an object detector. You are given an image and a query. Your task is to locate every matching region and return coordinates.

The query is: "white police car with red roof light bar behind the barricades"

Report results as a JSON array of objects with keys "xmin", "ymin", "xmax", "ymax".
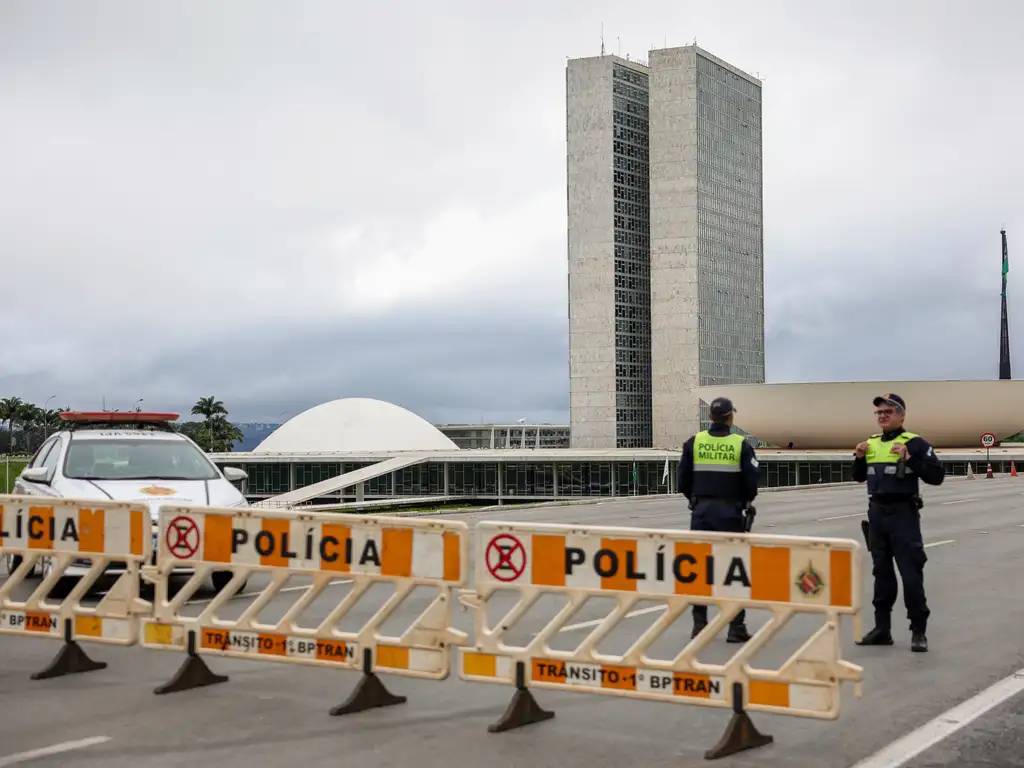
[{"xmin": 6, "ymin": 411, "xmax": 247, "ymax": 591}]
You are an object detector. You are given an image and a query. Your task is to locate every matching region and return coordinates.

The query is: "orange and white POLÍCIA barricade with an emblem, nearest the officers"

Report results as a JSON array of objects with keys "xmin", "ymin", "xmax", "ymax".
[{"xmin": 460, "ymin": 522, "xmax": 861, "ymax": 757}]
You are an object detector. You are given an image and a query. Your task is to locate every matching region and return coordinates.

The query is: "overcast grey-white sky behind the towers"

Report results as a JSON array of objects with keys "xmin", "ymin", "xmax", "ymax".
[{"xmin": 0, "ymin": 0, "xmax": 1024, "ymax": 421}]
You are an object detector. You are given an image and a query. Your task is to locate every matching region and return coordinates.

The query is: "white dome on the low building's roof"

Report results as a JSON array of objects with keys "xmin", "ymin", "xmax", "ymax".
[{"xmin": 256, "ymin": 397, "xmax": 458, "ymax": 454}]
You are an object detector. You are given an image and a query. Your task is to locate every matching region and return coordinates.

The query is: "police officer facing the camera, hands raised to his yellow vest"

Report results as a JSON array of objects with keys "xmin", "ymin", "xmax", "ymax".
[{"xmin": 853, "ymin": 393, "xmax": 945, "ymax": 652}]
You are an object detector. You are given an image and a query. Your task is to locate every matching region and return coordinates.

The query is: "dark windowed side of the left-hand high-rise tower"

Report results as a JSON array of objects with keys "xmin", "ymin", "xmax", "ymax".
[{"xmin": 611, "ymin": 63, "xmax": 651, "ymax": 447}]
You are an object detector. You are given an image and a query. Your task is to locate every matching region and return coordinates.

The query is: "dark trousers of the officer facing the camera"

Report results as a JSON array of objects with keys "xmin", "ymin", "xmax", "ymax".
[{"xmin": 867, "ymin": 500, "xmax": 931, "ymax": 632}]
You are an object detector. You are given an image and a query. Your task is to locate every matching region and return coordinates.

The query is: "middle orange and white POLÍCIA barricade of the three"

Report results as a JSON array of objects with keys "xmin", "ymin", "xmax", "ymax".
[{"xmin": 142, "ymin": 507, "xmax": 469, "ymax": 714}]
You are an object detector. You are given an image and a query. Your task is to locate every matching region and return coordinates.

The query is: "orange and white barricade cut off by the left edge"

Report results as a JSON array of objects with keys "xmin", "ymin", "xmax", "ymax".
[{"xmin": 0, "ymin": 496, "xmax": 153, "ymax": 679}]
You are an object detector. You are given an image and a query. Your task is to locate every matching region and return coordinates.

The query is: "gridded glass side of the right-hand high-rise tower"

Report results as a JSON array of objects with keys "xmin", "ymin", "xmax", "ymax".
[{"xmin": 696, "ymin": 53, "xmax": 764, "ymax": 385}]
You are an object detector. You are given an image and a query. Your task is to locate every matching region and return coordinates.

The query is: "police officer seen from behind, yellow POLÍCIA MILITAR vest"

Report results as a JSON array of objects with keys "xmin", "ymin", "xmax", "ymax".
[{"xmin": 677, "ymin": 397, "xmax": 758, "ymax": 643}]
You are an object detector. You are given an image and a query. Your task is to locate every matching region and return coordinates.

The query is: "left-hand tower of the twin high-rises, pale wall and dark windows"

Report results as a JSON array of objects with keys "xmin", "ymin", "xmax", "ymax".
[{"xmin": 565, "ymin": 56, "xmax": 651, "ymax": 449}]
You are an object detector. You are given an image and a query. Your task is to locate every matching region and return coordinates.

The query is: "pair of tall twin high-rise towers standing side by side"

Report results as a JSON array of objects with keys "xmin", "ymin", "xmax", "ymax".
[{"xmin": 565, "ymin": 45, "xmax": 764, "ymax": 450}]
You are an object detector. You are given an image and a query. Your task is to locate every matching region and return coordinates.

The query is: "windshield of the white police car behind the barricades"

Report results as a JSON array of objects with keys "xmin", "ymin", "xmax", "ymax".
[{"xmin": 65, "ymin": 437, "xmax": 217, "ymax": 480}]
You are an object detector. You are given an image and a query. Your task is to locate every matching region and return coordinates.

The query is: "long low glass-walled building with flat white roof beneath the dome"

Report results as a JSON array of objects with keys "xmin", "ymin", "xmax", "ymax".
[{"xmin": 211, "ymin": 446, "xmax": 1024, "ymax": 504}]
